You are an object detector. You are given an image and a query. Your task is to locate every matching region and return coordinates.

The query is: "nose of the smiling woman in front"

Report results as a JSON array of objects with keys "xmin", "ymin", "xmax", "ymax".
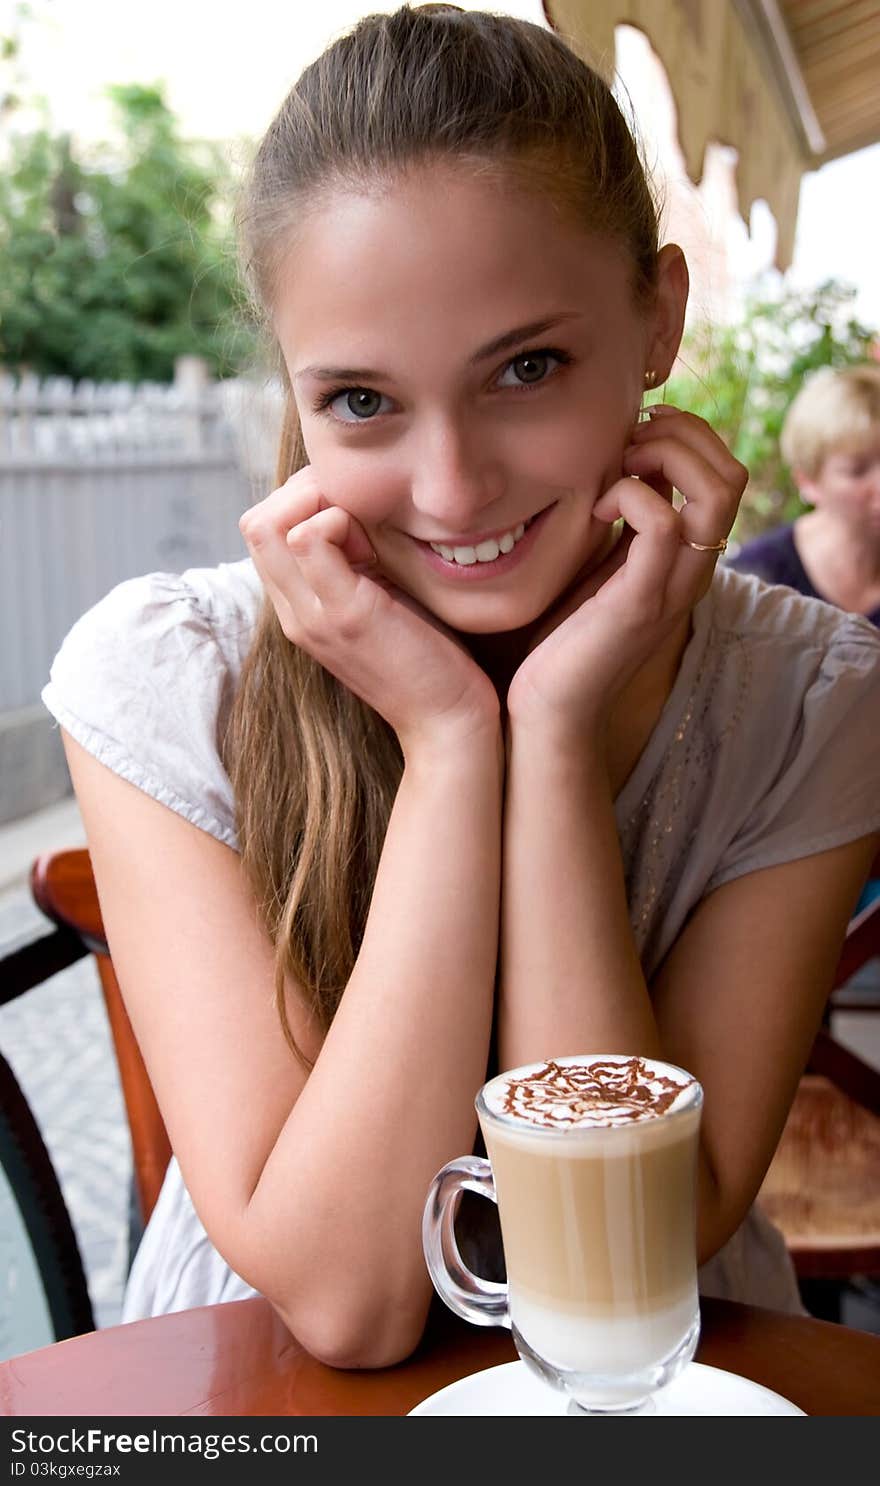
[{"xmin": 412, "ymin": 418, "xmax": 504, "ymax": 536}]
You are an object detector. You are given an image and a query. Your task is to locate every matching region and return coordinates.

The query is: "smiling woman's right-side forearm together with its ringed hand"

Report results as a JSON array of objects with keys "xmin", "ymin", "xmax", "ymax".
[{"xmin": 499, "ymin": 409, "xmax": 746, "ymax": 1067}]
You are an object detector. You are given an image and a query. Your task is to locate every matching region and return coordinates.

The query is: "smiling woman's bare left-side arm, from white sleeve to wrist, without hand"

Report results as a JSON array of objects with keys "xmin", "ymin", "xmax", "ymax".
[{"xmin": 65, "ymin": 707, "xmax": 504, "ymax": 1366}]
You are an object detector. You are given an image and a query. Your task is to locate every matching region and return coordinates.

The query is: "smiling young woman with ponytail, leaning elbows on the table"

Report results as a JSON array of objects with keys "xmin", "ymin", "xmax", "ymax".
[{"xmin": 43, "ymin": 6, "xmax": 880, "ymax": 1367}]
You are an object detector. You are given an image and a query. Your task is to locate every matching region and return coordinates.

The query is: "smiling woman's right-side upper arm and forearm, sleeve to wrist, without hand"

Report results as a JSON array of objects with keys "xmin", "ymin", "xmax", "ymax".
[{"xmin": 499, "ymin": 728, "xmax": 877, "ymax": 1263}]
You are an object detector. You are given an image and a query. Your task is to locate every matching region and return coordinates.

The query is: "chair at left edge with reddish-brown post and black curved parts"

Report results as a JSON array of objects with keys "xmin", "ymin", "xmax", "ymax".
[{"xmin": 0, "ymin": 849, "xmax": 171, "ymax": 1340}]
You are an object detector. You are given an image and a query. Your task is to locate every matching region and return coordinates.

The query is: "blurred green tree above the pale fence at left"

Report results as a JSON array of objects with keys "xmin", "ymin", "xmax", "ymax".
[{"xmin": 0, "ymin": 85, "xmax": 254, "ymax": 382}]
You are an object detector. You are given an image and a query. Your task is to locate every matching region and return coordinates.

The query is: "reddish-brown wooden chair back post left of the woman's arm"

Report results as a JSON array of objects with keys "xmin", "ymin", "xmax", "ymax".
[{"xmin": 31, "ymin": 849, "xmax": 171, "ymax": 1223}]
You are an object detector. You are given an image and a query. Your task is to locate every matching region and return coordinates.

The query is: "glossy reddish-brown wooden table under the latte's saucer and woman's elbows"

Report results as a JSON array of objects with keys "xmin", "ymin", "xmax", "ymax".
[{"xmin": 0, "ymin": 1300, "xmax": 880, "ymax": 1418}]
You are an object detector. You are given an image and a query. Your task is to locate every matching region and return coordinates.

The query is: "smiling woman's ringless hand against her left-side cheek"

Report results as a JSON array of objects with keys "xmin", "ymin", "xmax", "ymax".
[{"xmin": 239, "ymin": 467, "xmax": 499, "ymax": 758}]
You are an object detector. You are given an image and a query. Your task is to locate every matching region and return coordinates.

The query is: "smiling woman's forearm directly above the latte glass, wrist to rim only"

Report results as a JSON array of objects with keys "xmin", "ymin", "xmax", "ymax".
[{"xmin": 498, "ymin": 721, "xmax": 663, "ymax": 1068}]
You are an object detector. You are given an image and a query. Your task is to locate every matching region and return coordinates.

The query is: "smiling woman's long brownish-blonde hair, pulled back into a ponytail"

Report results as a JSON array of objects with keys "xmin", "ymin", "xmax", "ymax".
[{"xmin": 223, "ymin": 4, "xmax": 659, "ymax": 1062}]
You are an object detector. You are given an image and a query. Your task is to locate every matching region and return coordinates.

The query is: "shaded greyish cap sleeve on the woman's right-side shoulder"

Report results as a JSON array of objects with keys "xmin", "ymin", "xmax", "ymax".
[{"xmin": 706, "ymin": 615, "xmax": 880, "ymax": 892}]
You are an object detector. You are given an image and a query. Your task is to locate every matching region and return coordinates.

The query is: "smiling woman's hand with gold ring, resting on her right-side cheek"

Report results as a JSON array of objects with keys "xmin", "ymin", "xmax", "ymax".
[{"xmin": 507, "ymin": 404, "xmax": 748, "ymax": 740}]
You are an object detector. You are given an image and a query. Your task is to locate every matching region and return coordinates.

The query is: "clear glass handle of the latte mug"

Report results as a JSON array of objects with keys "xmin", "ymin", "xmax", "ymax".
[{"xmin": 422, "ymin": 1156, "xmax": 510, "ymax": 1327}]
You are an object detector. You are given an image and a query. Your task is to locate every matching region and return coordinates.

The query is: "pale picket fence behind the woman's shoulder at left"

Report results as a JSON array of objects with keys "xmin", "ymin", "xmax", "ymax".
[{"xmin": 0, "ymin": 358, "xmax": 281, "ymax": 820}]
